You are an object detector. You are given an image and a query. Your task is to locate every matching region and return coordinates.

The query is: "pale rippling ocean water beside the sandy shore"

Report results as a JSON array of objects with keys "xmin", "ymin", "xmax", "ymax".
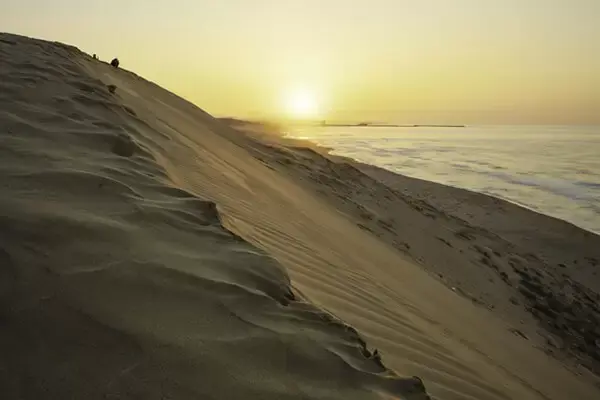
[{"xmin": 288, "ymin": 126, "xmax": 600, "ymax": 234}]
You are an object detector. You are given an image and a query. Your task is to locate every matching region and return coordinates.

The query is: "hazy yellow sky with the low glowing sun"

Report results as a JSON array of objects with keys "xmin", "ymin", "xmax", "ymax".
[{"xmin": 0, "ymin": 0, "xmax": 600, "ymax": 124}]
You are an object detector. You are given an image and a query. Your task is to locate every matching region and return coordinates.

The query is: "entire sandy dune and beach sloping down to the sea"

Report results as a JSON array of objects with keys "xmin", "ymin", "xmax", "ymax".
[{"xmin": 0, "ymin": 34, "xmax": 600, "ymax": 400}]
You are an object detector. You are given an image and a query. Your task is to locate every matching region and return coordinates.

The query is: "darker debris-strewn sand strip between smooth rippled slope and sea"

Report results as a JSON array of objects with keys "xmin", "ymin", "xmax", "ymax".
[{"xmin": 243, "ymin": 126, "xmax": 600, "ymax": 375}]
